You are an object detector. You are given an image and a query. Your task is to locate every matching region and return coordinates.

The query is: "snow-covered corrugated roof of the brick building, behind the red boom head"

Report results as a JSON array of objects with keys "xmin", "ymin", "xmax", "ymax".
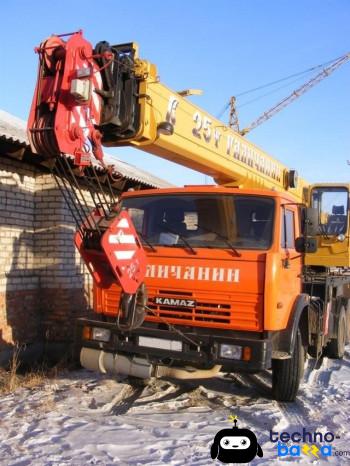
[{"xmin": 0, "ymin": 110, "xmax": 173, "ymax": 188}]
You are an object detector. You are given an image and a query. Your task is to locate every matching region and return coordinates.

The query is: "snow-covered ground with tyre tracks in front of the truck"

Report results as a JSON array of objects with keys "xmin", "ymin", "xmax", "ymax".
[{"xmin": 0, "ymin": 348, "xmax": 350, "ymax": 466}]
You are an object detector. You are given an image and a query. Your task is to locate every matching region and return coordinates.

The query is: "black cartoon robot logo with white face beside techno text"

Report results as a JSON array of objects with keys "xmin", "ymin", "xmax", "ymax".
[{"xmin": 210, "ymin": 416, "xmax": 264, "ymax": 463}]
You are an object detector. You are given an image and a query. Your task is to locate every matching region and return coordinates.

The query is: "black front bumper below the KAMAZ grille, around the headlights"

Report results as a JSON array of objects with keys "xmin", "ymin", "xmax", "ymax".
[{"xmin": 78, "ymin": 319, "xmax": 272, "ymax": 372}]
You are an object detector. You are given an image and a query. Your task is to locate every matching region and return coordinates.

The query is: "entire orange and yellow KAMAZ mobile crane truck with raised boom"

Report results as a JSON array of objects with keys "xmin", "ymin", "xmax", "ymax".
[{"xmin": 28, "ymin": 31, "xmax": 350, "ymax": 401}]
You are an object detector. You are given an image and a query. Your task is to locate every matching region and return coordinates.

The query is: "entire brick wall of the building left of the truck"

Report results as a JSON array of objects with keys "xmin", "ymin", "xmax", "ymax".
[{"xmin": 0, "ymin": 156, "xmax": 92, "ymax": 350}]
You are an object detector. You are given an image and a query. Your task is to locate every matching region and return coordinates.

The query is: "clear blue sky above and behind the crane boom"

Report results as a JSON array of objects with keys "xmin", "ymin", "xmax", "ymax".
[{"xmin": 0, "ymin": 0, "xmax": 350, "ymax": 185}]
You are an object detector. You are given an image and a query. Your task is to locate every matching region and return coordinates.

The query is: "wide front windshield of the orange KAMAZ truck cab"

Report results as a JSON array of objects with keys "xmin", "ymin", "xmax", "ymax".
[{"xmin": 122, "ymin": 194, "xmax": 275, "ymax": 249}]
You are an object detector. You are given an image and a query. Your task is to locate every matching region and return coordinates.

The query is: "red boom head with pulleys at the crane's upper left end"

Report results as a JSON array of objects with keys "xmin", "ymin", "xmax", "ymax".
[{"xmin": 28, "ymin": 31, "xmax": 104, "ymax": 166}]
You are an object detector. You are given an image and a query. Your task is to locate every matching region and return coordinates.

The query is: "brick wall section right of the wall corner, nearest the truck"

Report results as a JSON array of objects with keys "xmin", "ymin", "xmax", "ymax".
[{"xmin": 34, "ymin": 174, "xmax": 92, "ymax": 341}]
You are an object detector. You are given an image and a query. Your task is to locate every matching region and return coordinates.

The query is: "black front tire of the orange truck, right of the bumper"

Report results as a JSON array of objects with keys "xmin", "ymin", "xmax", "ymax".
[{"xmin": 272, "ymin": 330, "xmax": 305, "ymax": 401}]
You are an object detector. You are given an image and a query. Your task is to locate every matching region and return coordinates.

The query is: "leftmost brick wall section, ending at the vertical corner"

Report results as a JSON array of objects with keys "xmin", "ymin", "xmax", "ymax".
[{"xmin": 0, "ymin": 158, "xmax": 40, "ymax": 347}]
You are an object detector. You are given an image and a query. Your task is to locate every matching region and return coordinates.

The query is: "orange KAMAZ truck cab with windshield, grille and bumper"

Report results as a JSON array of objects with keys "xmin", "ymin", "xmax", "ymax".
[{"xmin": 78, "ymin": 186, "xmax": 308, "ymax": 400}]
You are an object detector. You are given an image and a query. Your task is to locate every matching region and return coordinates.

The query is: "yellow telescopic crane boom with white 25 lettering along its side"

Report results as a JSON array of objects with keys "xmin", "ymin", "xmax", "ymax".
[{"xmin": 103, "ymin": 44, "xmax": 307, "ymax": 202}]
